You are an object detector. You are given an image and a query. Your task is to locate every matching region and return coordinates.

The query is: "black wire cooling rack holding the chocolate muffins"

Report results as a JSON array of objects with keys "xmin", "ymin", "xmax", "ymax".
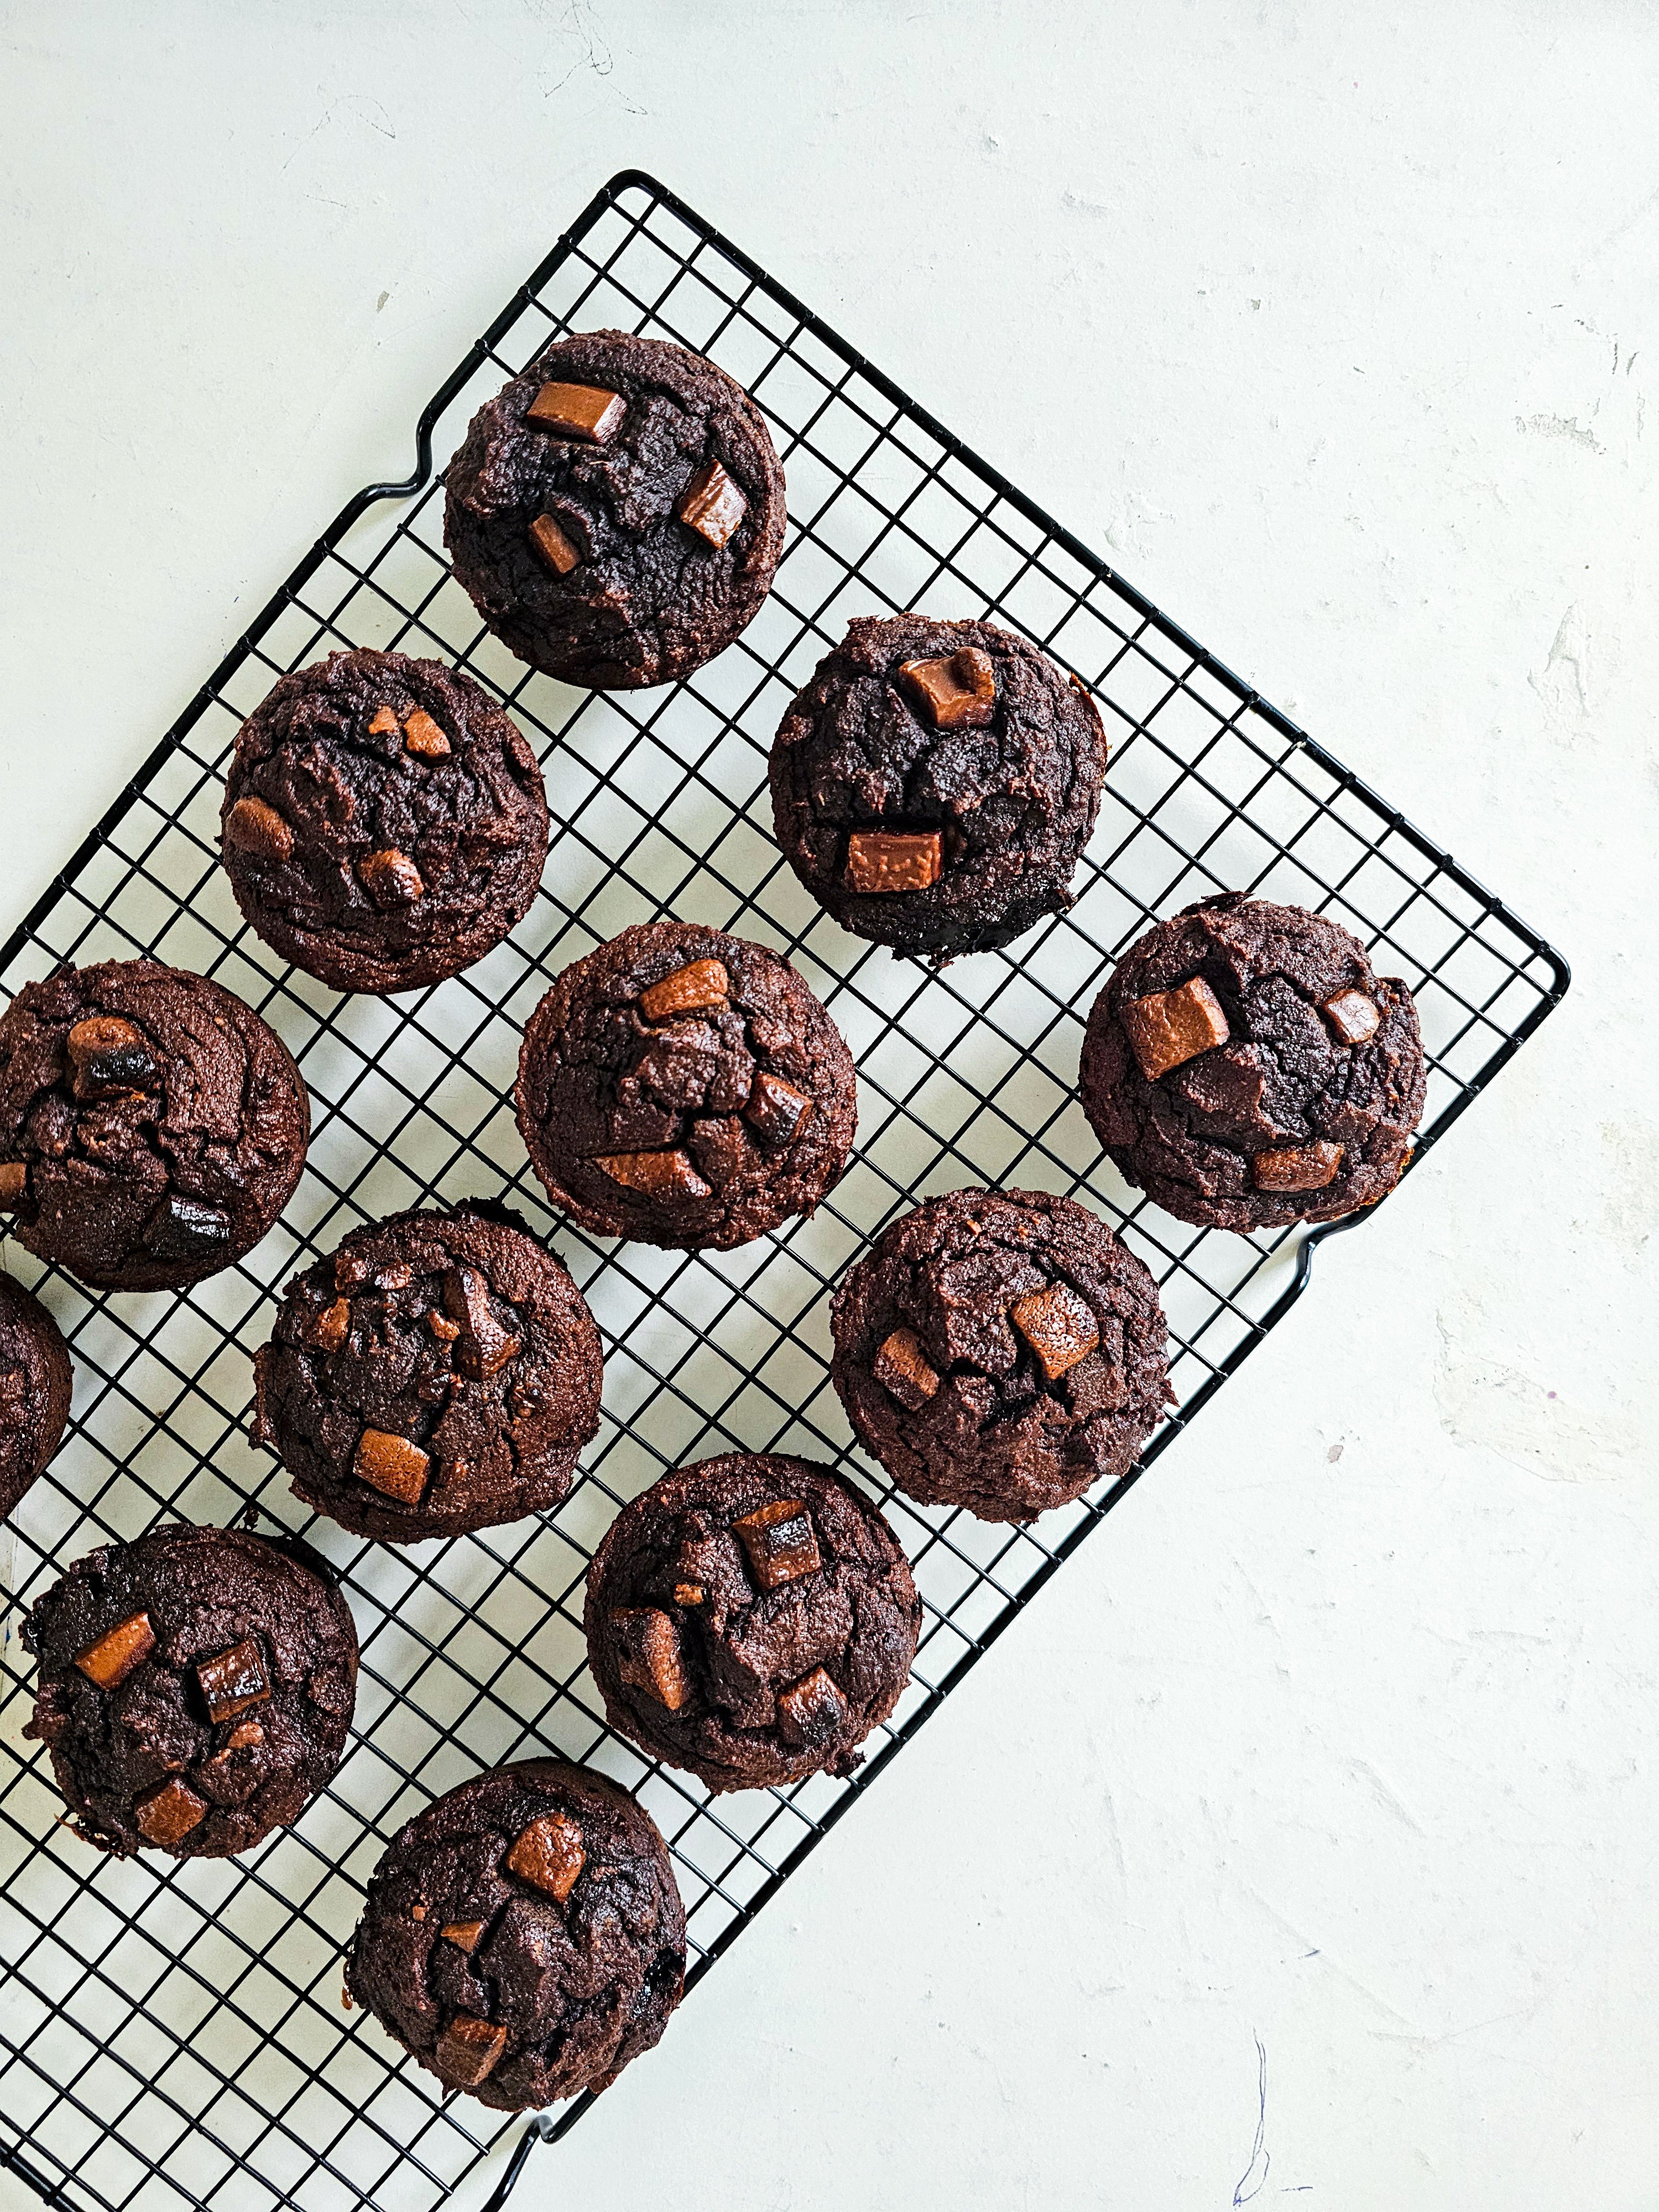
[{"xmin": 0, "ymin": 173, "xmax": 1568, "ymax": 2212}]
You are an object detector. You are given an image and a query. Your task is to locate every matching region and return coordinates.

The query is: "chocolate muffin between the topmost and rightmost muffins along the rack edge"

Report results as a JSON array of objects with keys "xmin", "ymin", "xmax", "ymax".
[{"xmin": 772, "ymin": 615, "xmax": 1106, "ymax": 967}]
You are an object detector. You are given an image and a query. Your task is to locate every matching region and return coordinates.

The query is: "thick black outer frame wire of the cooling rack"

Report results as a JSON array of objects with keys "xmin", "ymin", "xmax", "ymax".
[{"xmin": 0, "ymin": 168, "xmax": 1573, "ymax": 2212}]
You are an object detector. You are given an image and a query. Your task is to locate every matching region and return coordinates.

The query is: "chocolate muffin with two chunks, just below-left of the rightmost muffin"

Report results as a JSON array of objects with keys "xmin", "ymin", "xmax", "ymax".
[{"xmin": 830, "ymin": 1190, "xmax": 1170, "ymax": 1522}]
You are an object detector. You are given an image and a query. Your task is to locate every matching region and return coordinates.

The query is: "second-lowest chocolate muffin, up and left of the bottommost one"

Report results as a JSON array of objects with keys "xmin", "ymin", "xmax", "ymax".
[{"xmin": 22, "ymin": 1522, "xmax": 356, "ymax": 1858}]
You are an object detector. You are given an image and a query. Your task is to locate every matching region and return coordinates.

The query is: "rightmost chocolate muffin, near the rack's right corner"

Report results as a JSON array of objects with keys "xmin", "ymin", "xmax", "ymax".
[{"xmin": 1079, "ymin": 891, "xmax": 1425, "ymax": 1232}]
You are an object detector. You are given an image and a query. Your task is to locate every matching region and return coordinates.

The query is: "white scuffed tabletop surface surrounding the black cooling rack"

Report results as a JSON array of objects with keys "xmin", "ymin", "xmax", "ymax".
[{"xmin": 0, "ymin": 0, "xmax": 1659, "ymax": 2212}]
